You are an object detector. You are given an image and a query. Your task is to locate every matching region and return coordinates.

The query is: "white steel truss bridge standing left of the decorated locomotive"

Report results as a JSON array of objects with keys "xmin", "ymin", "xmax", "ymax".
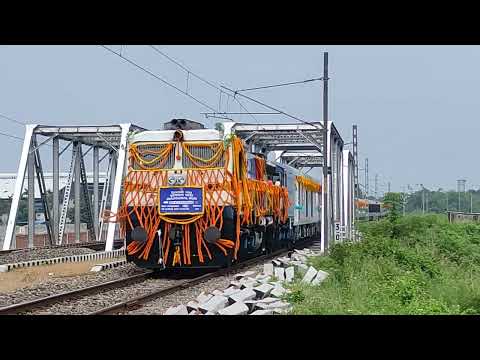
[{"xmin": 3, "ymin": 123, "xmax": 145, "ymax": 250}]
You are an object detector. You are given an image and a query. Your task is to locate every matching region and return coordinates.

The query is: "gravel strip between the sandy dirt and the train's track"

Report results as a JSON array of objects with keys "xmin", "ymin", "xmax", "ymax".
[{"xmin": 0, "ymin": 263, "xmax": 145, "ymax": 307}]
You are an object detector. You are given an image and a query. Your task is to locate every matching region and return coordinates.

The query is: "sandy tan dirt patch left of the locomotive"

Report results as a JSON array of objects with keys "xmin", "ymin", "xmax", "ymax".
[{"xmin": 0, "ymin": 258, "xmax": 123, "ymax": 293}]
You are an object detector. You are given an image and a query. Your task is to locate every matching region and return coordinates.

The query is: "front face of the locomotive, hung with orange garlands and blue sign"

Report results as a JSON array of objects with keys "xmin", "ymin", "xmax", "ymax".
[{"xmin": 119, "ymin": 119, "xmax": 243, "ymax": 269}]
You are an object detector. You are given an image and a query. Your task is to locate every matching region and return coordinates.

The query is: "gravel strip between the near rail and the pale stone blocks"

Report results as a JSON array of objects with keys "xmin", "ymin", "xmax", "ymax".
[{"xmin": 128, "ymin": 263, "xmax": 263, "ymax": 315}]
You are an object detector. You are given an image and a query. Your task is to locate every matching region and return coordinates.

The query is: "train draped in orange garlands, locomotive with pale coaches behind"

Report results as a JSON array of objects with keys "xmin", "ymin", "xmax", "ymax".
[{"xmin": 115, "ymin": 119, "xmax": 321, "ymax": 270}]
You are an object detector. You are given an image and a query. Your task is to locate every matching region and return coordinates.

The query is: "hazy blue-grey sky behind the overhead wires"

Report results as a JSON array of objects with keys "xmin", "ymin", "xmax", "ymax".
[{"xmin": 0, "ymin": 45, "xmax": 480, "ymax": 193}]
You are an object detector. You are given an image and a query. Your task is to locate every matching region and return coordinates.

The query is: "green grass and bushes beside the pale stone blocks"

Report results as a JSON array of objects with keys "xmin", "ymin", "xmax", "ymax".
[{"xmin": 287, "ymin": 215, "xmax": 480, "ymax": 315}]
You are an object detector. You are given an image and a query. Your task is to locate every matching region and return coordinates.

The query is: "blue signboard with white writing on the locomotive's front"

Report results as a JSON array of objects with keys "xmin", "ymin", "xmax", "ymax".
[{"xmin": 160, "ymin": 187, "xmax": 203, "ymax": 215}]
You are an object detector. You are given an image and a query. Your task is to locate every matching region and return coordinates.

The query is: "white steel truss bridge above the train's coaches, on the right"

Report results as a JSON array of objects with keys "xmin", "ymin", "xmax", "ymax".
[{"xmin": 232, "ymin": 121, "xmax": 353, "ymax": 251}]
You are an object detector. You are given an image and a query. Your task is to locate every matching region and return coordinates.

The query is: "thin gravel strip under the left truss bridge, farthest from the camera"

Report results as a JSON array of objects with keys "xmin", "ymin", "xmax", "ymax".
[{"xmin": 0, "ymin": 247, "xmax": 96, "ymax": 264}]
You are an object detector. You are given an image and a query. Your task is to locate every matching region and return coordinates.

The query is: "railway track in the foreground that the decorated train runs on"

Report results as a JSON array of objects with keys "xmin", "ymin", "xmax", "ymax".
[{"xmin": 0, "ymin": 240, "xmax": 312, "ymax": 315}]
